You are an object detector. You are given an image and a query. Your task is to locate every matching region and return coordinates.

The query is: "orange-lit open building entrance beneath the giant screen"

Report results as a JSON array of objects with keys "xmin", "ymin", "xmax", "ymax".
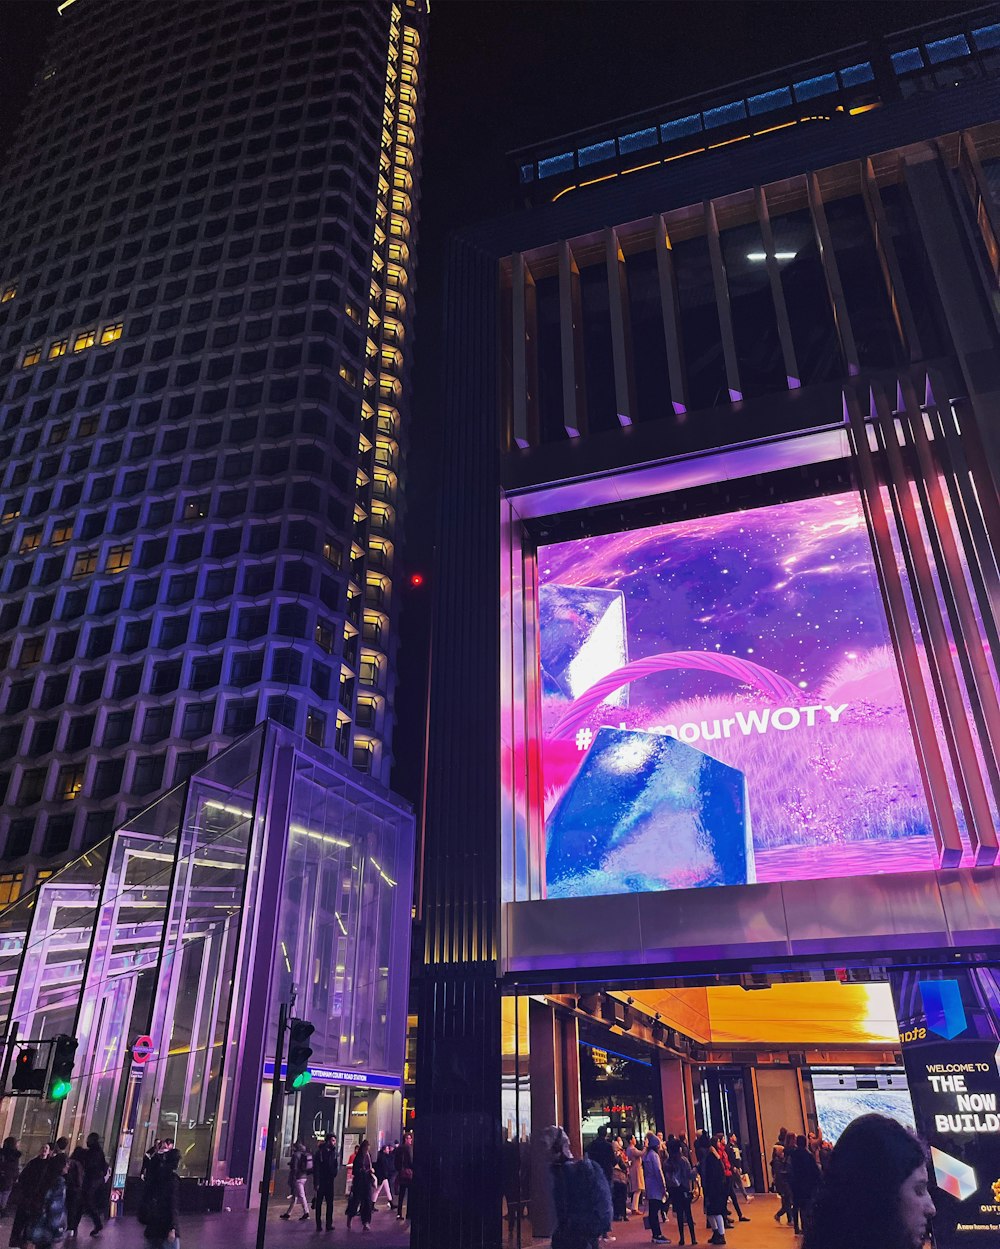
[{"xmin": 503, "ymin": 964, "xmax": 1000, "ymax": 1249}]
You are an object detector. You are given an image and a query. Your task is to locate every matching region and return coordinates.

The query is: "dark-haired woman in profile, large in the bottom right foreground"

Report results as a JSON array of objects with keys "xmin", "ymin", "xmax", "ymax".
[{"xmin": 803, "ymin": 1114, "xmax": 935, "ymax": 1249}]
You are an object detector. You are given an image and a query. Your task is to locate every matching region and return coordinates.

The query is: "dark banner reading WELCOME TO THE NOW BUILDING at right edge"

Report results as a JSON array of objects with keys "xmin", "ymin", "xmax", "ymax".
[{"xmin": 891, "ymin": 967, "xmax": 1000, "ymax": 1249}]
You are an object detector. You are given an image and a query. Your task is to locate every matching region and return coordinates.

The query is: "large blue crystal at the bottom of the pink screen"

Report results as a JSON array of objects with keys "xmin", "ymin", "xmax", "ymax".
[{"xmin": 546, "ymin": 728, "xmax": 755, "ymax": 898}]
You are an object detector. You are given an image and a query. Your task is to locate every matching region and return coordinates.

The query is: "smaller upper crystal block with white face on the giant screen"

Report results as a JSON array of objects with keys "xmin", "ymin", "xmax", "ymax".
[{"xmin": 538, "ymin": 585, "xmax": 628, "ymax": 707}]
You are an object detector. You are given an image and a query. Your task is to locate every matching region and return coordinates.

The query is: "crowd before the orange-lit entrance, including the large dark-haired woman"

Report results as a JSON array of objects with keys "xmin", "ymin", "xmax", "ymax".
[{"xmin": 541, "ymin": 1114, "xmax": 935, "ymax": 1249}]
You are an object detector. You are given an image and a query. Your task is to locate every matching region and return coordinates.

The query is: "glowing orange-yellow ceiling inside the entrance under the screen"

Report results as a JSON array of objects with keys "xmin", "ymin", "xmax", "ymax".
[{"xmin": 614, "ymin": 982, "xmax": 899, "ymax": 1047}]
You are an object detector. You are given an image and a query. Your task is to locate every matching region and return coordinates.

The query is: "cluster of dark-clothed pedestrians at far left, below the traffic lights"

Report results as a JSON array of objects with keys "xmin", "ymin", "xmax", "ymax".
[{"xmin": 0, "ymin": 1133, "xmax": 109, "ymax": 1249}]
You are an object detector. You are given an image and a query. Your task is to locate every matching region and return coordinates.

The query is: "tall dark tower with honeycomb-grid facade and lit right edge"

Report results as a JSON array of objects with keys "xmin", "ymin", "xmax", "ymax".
[{"xmin": 0, "ymin": 0, "xmax": 426, "ymax": 898}]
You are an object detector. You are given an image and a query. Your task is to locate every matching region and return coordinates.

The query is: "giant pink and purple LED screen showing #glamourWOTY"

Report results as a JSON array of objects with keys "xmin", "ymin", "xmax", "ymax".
[{"xmin": 538, "ymin": 493, "xmax": 938, "ymax": 898}]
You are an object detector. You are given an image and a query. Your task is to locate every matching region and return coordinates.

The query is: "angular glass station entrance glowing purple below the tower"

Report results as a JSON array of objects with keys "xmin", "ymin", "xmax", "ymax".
[{"xmin": 0, "ymin": 724, "xmax": 413, "ymax": 1208}]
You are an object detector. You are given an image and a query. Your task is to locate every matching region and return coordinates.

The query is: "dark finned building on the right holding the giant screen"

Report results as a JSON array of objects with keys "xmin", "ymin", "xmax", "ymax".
[{"xmin": 413, "ymin": 6, "xmax": 1000, "ymax": 1247}]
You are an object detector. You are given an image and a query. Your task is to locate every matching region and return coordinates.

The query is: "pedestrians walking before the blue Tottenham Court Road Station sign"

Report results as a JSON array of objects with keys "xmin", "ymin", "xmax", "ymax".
[{"xmin": 274, "ymin": 1133, "xmax": 413, "ymax": 1232}]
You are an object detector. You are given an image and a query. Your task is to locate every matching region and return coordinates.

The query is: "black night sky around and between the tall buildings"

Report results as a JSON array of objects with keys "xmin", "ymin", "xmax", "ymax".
[{"xmin": 0, "ymin": 0, "xmax": 969, "ymax": 796}]
